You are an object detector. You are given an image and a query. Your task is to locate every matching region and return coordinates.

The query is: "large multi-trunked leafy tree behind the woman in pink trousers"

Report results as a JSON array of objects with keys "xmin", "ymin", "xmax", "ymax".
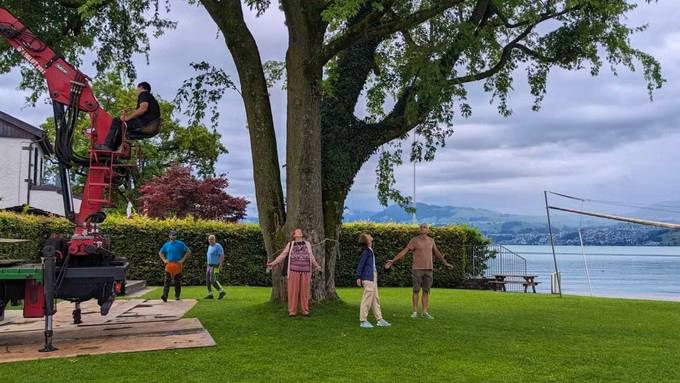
[{"xmin": 0, "ymin": 0, "xmax": 663, "ymax": 300}]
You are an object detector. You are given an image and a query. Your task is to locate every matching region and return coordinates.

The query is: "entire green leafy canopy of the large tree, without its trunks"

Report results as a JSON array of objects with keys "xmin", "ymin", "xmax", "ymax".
[{"xmin": 0, "ymin": 0, "xmax": 665, "ymax": 213}]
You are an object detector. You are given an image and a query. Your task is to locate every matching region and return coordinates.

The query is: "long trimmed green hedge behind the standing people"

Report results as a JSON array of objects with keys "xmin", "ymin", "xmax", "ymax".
[{"xmin": 0, "ymin": 213, "xmax": 488, "ymax": 287}]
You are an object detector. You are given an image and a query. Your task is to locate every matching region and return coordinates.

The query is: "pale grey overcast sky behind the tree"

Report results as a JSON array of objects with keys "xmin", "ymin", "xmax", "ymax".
[{"xmin": 0, "ymin": 0, "xmax": 680, "ymax": 219}]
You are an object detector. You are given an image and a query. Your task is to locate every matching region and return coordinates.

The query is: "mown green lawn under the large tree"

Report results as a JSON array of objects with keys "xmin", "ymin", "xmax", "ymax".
[{"xmin": 0, "ymin": 287, "xmax": 680, "ymax": 383}]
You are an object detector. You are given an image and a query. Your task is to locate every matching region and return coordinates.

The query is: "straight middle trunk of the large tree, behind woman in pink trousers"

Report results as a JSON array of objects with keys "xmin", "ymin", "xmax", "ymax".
[{"xmin": 282, "ymin": 0, "xmax": 328, "ymax": 302}]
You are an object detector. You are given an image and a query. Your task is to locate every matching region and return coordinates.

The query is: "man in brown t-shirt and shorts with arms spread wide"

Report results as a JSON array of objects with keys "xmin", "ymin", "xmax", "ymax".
[{"xmin": 385, "ymin": 223, "xmax": 453, "ymax": 319}]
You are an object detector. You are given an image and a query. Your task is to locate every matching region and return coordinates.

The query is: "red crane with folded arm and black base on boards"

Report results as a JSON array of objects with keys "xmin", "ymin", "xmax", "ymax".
[{"xmin": 0, "ymin": 7, "xmax": 143, "ymax": 351}]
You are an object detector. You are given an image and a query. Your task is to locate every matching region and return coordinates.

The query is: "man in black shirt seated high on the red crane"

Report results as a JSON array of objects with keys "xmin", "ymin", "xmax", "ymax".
[{"xmin": 95, "ymin": 82, "xmax": 161, "ymax": 150}]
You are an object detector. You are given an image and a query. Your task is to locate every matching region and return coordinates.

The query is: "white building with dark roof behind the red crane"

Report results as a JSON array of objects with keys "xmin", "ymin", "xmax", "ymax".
[{"xmin": 0, "ymin": 111, "xmax": 80, "ymax": 215}]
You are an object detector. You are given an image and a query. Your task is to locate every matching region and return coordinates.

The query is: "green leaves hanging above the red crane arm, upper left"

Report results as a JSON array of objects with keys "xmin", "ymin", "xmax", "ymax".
[{"xmin": 0, "ymin": 0, "xmax": 177, "ymax": 103}]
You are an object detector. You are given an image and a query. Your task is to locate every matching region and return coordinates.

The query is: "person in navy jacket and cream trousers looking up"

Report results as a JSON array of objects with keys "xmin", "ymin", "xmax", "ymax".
[{"xmin": 357, "ymin": 233, "xmax": 390, "ymax": 328}]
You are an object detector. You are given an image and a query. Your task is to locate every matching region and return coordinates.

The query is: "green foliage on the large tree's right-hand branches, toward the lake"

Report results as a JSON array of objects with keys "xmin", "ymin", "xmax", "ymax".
[{"xmin": 340, "ymin": 0, "xmax": 665, "ymax": 205}]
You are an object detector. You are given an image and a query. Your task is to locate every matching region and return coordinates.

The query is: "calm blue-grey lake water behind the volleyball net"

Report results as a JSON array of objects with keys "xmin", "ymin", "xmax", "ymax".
[{"xmin": 505, "ymin": 245, "xmax": 680, "ymax": 301}]
